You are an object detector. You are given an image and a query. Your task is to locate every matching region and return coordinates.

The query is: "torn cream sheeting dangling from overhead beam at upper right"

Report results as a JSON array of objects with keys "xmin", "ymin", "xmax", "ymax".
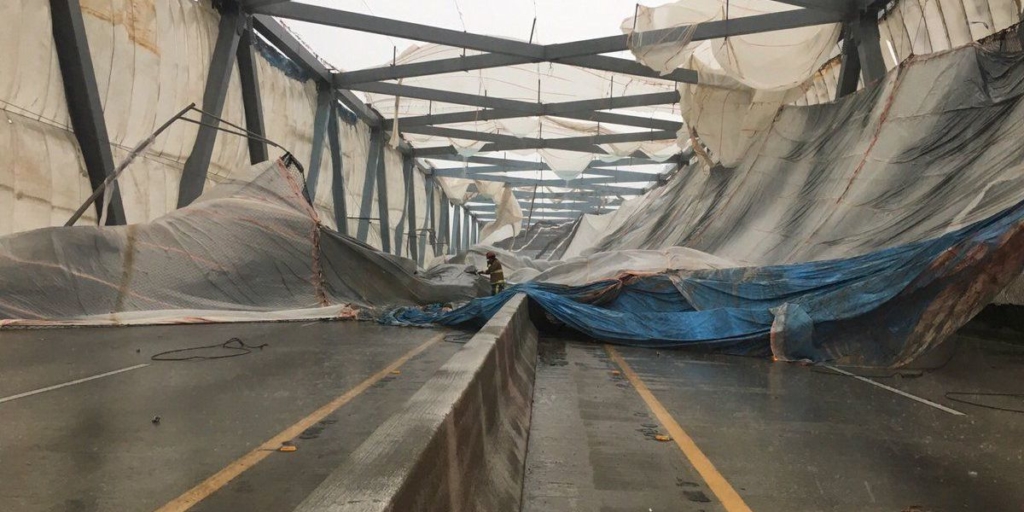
[{"xmin": 622, "ymin": 0, "xmax": 840, "ymax": 166}]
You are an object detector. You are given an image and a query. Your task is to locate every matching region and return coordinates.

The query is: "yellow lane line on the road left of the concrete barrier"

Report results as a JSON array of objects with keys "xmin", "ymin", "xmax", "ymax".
[{"xmin": 157, "ymin": 334, "xmax": 444, "ymax": 512}]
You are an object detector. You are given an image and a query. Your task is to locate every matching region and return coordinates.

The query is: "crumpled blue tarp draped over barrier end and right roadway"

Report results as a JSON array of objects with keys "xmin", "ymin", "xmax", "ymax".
[{"xmin": 381, "ymin": 197, "xmax": 1024, "ymax": 364}]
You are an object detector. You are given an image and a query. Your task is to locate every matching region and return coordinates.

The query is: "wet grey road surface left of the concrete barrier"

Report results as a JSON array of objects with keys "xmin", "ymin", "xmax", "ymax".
[{"xmin": 0, "ymin": 322, "xmax": 460, "ymax": 512}]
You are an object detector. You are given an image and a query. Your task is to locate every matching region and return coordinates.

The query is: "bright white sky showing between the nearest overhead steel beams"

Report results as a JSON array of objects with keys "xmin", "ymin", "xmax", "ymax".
[{"xmin": 285, "ymin": 0, "xmax": 647, "ymax": 71}]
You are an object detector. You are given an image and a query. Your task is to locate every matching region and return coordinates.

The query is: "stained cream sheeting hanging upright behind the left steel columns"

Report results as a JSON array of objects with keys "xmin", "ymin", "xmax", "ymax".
[{"xmin": 0, "ymin": 0, "xmax": 440, "ymax": 266}]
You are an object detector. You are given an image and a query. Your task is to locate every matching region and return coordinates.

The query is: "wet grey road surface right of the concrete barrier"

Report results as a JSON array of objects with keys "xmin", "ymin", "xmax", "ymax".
[{"xmin": 523, "ymin": 336, "xmax": 1024, "ymax": 512}]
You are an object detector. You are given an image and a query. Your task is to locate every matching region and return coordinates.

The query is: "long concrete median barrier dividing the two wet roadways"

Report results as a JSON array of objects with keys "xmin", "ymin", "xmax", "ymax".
[{"xmin": 296, "ymin": 295, "xmax": 537, "ymax": 512}]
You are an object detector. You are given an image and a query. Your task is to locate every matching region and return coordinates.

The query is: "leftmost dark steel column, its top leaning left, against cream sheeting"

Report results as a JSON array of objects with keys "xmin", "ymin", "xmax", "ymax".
[{"xmin": 49, "ymin": 0, "xmax": 125, "ymax": 225}]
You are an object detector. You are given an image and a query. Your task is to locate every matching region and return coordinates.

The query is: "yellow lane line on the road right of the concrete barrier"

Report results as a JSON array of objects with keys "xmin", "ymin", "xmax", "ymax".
[{"xmin": 604, "ymin": 345, "xmax": 751, "ymax": 512}]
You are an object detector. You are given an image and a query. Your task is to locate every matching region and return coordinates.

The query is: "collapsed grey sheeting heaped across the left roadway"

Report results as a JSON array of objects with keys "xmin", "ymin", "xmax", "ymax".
[{"xmin": 0, "ymin": 161, "xmax": 480, "ymax": 326}]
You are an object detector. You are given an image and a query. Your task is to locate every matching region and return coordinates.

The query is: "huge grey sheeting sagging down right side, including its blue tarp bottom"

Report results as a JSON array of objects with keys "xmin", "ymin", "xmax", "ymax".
[{"xmin": 386, "ymin": 41, "xmax": 1024, "ymax": 366}]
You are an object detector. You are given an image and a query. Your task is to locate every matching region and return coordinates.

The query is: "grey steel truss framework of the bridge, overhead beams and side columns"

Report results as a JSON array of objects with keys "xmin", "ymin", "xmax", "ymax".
[{"xmin": 50, "ymin": 0, "xmax": 885, "ymax": 248}]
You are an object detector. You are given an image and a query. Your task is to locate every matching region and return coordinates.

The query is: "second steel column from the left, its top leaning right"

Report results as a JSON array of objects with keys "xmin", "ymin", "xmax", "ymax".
[{"xmin": 178, "ymin": 2, "xmax": 243, "ymax": 208}]
